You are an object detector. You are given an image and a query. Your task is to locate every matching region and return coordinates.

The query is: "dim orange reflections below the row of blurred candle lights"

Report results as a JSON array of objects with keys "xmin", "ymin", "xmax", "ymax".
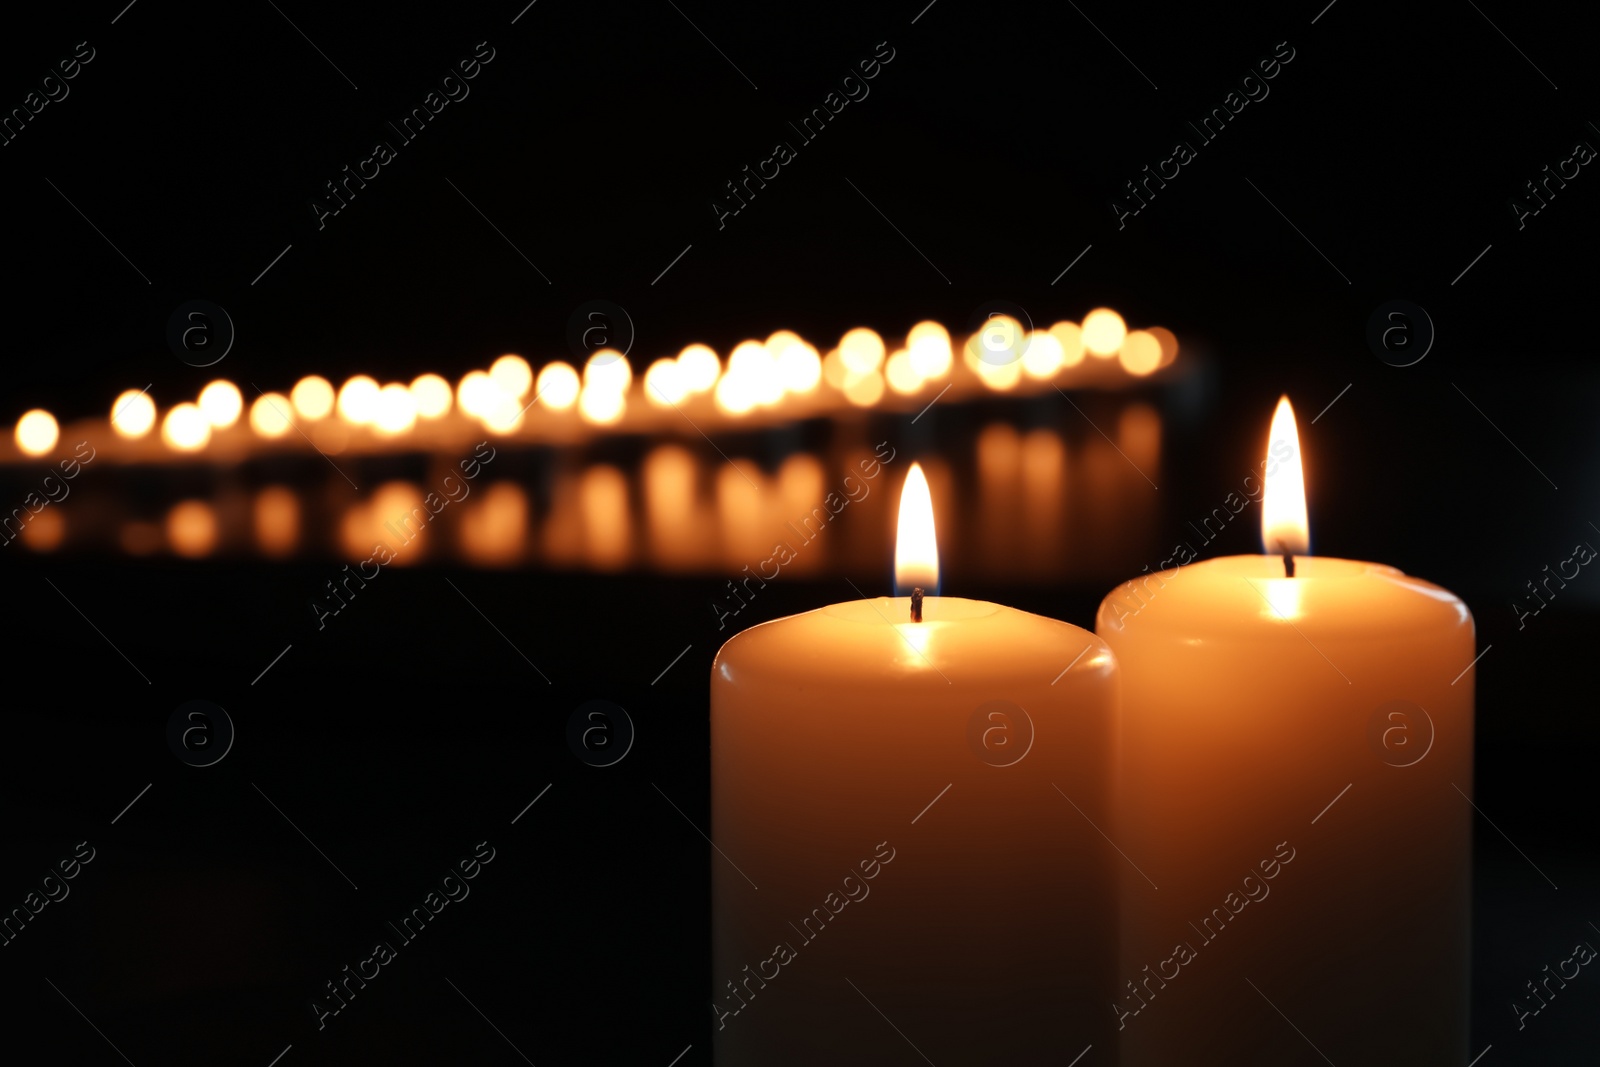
[{"xmin": 6, "ymin": 402, "xmax": 1162, "ymax": 579}]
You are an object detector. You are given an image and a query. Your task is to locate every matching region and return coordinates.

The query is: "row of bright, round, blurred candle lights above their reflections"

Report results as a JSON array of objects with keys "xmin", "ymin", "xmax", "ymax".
[{"xmin": 0, "ymin": 307, "xmax": 1178, "ymax": 462}]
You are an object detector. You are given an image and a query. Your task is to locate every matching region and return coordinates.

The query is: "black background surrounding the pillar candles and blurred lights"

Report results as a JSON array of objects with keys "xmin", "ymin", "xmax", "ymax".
[{"xmin": 0, "ymin": 0, "xmax": 1600, "ymax": 1065}]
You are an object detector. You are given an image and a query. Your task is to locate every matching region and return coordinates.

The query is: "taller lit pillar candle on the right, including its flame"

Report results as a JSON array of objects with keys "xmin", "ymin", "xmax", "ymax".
[{"xmin": 1096, "ymin": 398, "xmax": 1474, "ymax": 1067}]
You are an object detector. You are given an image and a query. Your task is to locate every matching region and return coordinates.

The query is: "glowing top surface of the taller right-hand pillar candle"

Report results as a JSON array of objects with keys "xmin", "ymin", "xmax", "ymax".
[{"xmin": 1096, "ymin": 555, "xmax": 1472, "ymax": 640}]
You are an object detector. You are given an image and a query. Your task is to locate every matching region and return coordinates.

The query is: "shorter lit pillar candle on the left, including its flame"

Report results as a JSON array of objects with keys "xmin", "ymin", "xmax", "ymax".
[{"xmin": 710, "ymin": 461, "xmax": 1118, "ymax": 1067}]
